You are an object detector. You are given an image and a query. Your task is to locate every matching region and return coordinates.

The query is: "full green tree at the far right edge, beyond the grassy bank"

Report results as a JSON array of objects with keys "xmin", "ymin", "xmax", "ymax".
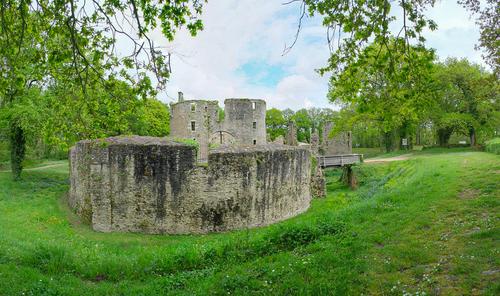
[{"xmin": 431, "ymin": 58, "xmax": 500, "ymax": 146}]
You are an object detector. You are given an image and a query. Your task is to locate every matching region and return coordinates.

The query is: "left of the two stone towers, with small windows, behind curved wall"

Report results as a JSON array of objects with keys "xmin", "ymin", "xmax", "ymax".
[{"xmin": 170, "ymin": 100, "xmax": 219, "ymax": 160}]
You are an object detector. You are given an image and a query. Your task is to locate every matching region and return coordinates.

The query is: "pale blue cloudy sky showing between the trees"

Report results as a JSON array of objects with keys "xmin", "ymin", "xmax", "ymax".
[{"xmin": 153, "ymin": 0, "xmax": 484, "ymax": 110}]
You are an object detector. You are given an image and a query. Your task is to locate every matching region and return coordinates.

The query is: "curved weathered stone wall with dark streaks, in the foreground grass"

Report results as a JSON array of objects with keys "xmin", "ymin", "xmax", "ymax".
[{"xmin": 69, "ymin": 137, "xmax": 311, "ymax": 234}]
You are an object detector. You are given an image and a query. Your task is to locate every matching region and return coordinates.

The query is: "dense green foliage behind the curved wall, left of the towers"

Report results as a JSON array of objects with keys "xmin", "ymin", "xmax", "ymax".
[{"xmin": 38, "ymin": 81, "xmax": 170, "ymax": 152}]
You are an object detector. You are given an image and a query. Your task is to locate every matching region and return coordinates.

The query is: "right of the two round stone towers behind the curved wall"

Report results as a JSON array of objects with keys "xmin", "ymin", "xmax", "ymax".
[{"xmin": 223, "ymin": 99, "xmax": 266, "ymax": 146}]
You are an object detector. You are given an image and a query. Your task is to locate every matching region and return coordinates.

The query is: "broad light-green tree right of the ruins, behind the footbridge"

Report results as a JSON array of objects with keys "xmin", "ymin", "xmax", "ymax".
[{"xmin": 328, "ymin": 39, "xmax": 434, "ymax": 151}]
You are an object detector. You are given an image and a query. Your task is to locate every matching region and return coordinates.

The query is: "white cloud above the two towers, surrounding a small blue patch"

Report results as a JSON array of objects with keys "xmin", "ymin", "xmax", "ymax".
[{"xmin": 150, "ymin": 0, "xmax": 328, "ymax": 109}]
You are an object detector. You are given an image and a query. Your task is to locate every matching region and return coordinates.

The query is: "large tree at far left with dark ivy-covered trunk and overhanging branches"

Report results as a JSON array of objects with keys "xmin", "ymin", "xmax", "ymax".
[{"xmin": 0, "ymin": 0, "xmax": 203, "ymax": 179}]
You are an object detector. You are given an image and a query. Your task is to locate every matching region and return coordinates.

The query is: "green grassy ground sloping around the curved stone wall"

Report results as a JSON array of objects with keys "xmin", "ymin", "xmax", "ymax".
[{"xmin": 0, "ymin": 150, "xmax": 500, "ymax": 295}]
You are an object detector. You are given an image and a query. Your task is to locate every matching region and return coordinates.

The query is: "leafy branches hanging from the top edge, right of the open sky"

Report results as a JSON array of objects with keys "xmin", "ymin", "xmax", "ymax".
[{"xmin": 303, "ymin": 0, "xmax": 437, "ymax": 77}]
